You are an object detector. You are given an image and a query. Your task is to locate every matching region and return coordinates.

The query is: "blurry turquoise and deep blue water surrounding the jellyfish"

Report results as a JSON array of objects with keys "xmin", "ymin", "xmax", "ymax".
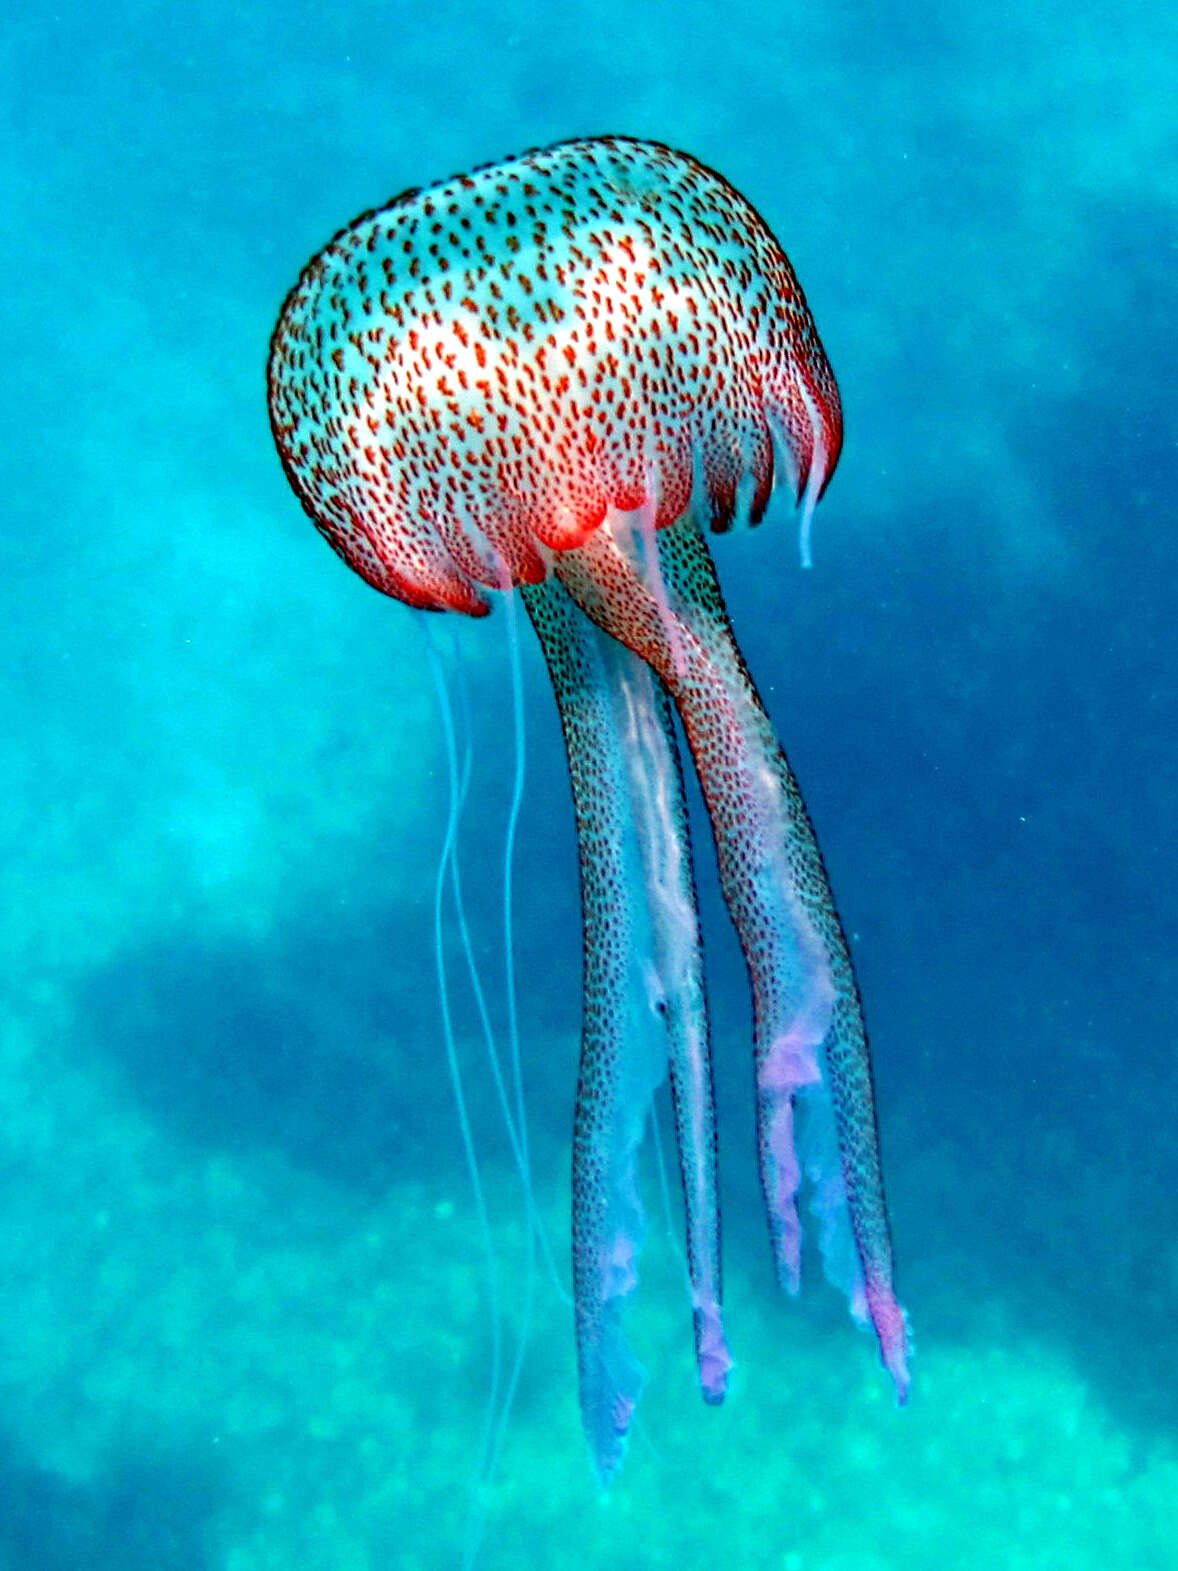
[{"xmin": 0, "ymin": 0, "xmax": 1178, "ymax": 1571}]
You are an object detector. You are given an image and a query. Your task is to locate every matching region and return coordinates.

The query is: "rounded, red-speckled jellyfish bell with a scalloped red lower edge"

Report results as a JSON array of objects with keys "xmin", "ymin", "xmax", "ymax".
[{"xmin": 270, "ymin": 138, "xmax": 842, "ymax": 611}]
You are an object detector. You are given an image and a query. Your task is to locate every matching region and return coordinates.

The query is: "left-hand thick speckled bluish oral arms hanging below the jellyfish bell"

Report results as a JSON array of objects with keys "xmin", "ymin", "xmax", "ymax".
[{"xmin": 523, "ymin": 580, "xmax": 730, "ymax": 1483}]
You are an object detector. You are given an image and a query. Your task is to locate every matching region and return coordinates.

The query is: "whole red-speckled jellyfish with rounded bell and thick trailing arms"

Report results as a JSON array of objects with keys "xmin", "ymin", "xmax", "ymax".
[{"xmin": 269, "ymin": 137, "xmax": 908, "ymax": 1481}]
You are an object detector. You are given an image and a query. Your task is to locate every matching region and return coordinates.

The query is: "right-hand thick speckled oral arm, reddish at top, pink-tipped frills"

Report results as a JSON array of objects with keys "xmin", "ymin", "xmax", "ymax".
[{"xmin": 556, "ymin": 515, "xmax": 908, "ymax": 1401}]
